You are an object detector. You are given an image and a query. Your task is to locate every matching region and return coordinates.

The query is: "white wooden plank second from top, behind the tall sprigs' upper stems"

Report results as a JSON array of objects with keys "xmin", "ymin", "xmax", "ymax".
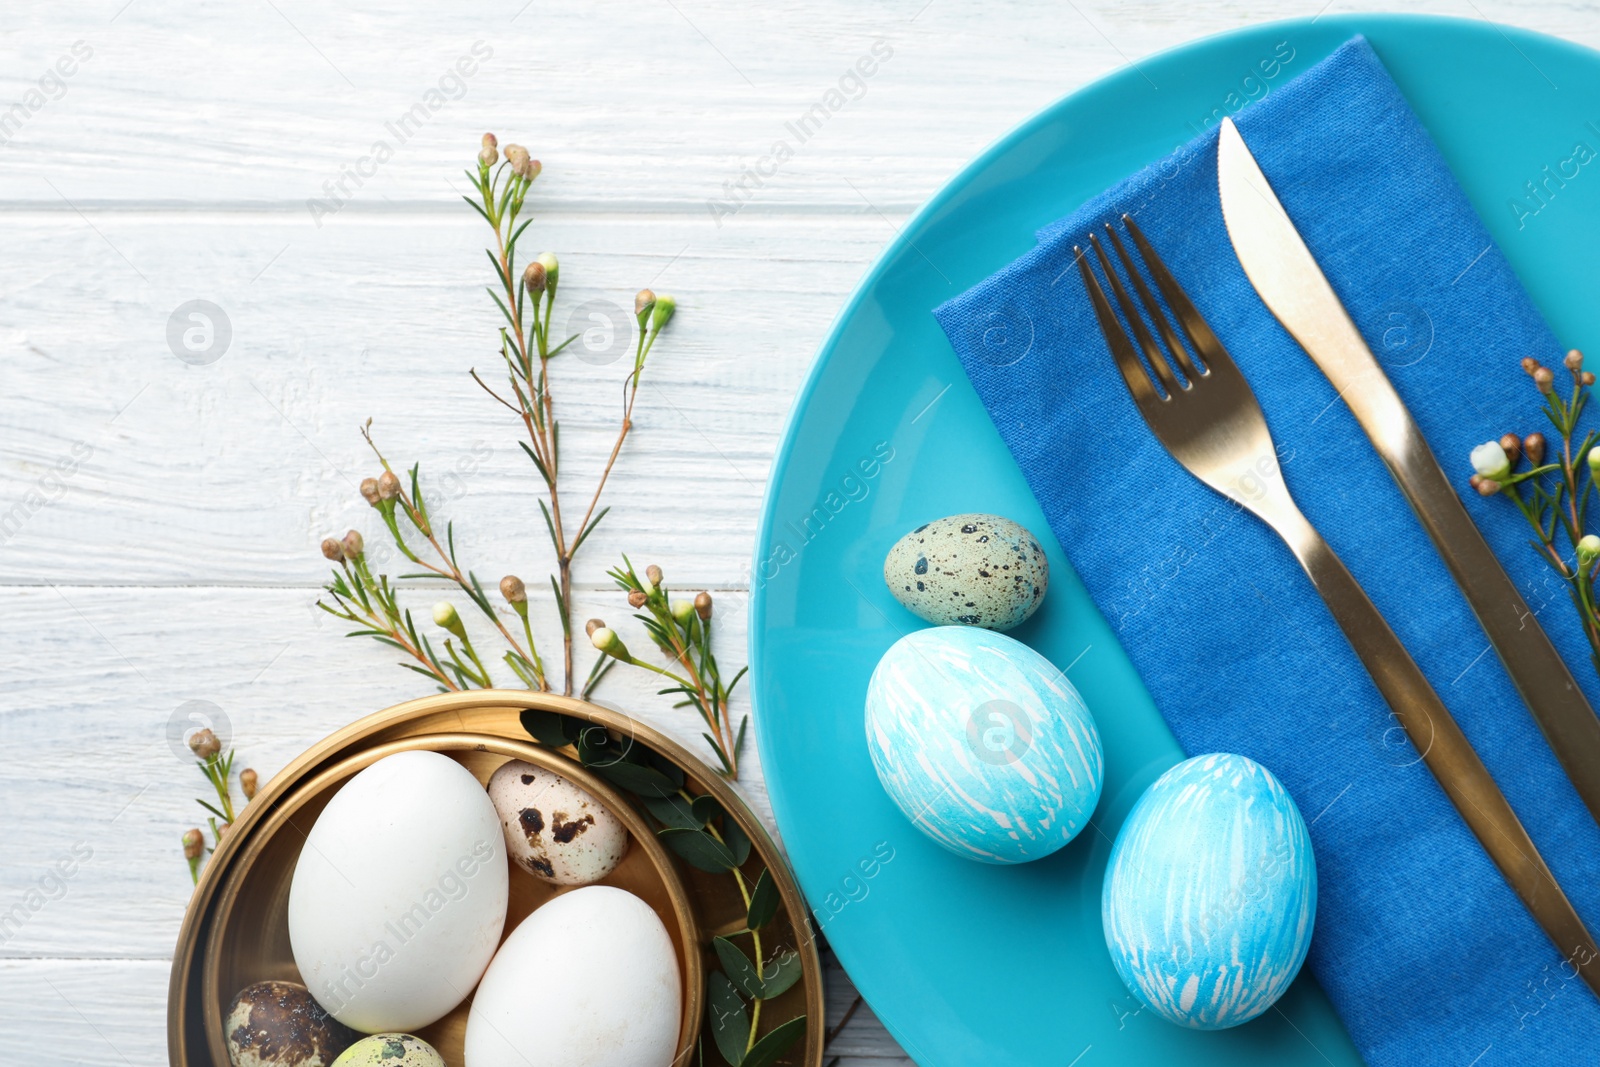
[{"xmin": 0, "ymin": 205, "xmax": 893, "ymax": 587}]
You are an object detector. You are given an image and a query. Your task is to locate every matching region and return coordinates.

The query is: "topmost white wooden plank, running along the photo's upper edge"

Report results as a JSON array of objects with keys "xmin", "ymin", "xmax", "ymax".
[{"xmin": 9, "ymin": 0, "xmax": 1600, "ymax": 211}]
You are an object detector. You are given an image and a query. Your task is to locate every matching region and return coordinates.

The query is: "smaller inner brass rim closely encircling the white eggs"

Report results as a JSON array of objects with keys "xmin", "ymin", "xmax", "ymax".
[{"xmin": 200, "ymin": 733, "xmax": 706, "ymax": 1067}]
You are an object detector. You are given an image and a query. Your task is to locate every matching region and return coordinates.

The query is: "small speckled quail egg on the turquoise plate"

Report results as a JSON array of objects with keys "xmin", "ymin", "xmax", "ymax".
[{"xmin": 883, "ymin": 514, "xmax": 1050, "ymax": 630}]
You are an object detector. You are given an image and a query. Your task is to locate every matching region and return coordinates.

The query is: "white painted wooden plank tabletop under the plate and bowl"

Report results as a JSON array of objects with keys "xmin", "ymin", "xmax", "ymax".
[{"xmin": 0, "ymin": 0, "xmax": 1600, "ymax": 1067}]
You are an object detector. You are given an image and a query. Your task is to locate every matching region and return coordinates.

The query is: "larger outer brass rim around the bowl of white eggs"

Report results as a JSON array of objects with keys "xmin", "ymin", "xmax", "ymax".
[{"xmin": 166, "ymin": 689, "xmax": 826, "ymax": 1067}]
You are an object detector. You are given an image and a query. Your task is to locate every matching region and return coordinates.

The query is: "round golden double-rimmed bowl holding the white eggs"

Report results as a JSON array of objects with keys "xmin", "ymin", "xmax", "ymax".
[{"xmin": 168, "ymin": 689, "xmax": 824, "ymax": 1067}]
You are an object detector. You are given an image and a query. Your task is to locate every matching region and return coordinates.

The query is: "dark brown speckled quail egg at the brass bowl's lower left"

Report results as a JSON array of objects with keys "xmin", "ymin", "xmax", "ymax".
[{"xmin": 222, "ymin": 982, "xmax": 358, "ymax": 1067}]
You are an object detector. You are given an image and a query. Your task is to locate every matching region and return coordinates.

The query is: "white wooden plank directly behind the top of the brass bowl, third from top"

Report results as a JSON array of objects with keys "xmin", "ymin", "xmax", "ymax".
[{"xmin": 0, "ymin": 587, "xmax": 771, "ymax": 959}]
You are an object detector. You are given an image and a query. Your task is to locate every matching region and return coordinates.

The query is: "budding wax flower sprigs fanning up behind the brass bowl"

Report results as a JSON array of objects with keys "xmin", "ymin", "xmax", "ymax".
[{"xmin": 308, "ymin": 134, "xmax": 744, "ymax": 777}]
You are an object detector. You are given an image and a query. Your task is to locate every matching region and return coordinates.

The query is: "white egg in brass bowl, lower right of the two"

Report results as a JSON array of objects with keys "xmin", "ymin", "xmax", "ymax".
[{"xmin": 464, "ymin": 886, "xmax": 683, "ymax": 1067}]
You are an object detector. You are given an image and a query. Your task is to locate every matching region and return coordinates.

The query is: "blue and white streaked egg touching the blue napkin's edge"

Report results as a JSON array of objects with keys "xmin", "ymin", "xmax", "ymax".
[{"xmin": 1101, "ymin": 753, "xmax": 1317, "ymax": 1030}]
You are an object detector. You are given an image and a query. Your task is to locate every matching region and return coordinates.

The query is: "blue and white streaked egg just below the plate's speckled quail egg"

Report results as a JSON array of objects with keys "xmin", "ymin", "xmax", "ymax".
[{"xmin": 867, "ymin": 625, "xmax": 1102, "ymax": 864}]
